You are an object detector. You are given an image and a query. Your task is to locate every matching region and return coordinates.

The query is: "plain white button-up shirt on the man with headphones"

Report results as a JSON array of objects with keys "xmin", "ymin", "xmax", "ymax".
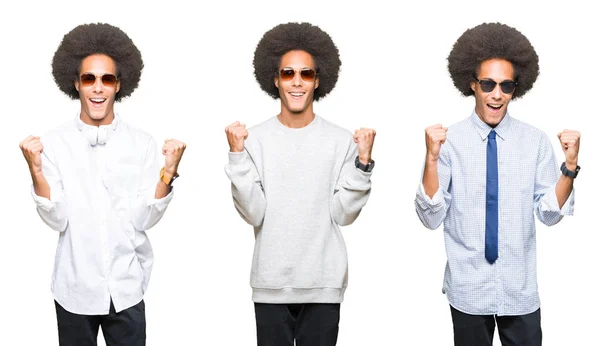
[{"xmin": 32, "ymin": 116, "xmax": 173, "ymax": 315}]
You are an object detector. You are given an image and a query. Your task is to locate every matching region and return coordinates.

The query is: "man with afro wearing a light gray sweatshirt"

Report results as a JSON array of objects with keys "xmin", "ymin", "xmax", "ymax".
[{"xmin": 225, "ymin": 23, "xmax": 375, "ymax": 346}]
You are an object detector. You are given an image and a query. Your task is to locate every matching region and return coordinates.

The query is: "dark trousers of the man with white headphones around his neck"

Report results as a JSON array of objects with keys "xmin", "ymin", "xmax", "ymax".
[{"xmin": 54, "ymin": 300, "xmax": 146, "ymax": 346}]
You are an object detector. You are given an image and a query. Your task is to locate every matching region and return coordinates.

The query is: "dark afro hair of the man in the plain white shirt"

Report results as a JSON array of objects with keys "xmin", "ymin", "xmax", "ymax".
[{"xmin": 52, "ymin": 23, "xmax": 144, "ymax": 101}]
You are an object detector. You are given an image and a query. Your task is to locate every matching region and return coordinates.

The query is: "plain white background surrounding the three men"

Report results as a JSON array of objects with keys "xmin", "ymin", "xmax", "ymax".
[{"xmin": 0, "ymin": 0, "xmax": 600, "ymax": 346}]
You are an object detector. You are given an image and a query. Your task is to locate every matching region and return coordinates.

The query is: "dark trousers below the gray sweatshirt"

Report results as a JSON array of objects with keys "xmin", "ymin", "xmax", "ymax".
[{"xmin": 254, "ymin": 303, "xmax": 340, "ymax": 346}]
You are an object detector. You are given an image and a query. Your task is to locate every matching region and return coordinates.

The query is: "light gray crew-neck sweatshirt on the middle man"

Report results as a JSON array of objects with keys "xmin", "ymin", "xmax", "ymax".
[{"xmin": 225, "ymin": 116, "xmax": 371, "ymax": 304}]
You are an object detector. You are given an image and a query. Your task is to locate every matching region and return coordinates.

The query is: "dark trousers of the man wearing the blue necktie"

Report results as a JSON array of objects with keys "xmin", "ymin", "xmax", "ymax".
[{"xmin": 450, "ymin": 306, "xmax": 542, "ymax": 346}]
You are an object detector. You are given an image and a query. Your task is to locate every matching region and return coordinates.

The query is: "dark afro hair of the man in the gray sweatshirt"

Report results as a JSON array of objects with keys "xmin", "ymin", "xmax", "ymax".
[{"xmin": 254, "ymin": 23, "xmax": 342, "ymax": 101}]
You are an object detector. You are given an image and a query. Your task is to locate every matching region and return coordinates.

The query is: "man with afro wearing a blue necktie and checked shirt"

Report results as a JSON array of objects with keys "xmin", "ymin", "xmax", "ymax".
[{"xmin": 415, "ymin": 23, "xmax": 580, "ymax": 346}]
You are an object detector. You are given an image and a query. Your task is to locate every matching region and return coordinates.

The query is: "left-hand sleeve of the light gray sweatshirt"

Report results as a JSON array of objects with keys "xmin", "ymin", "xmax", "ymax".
[{"xmin": 225, "ymin": 150, "xmax": 267, "ymax": 227}]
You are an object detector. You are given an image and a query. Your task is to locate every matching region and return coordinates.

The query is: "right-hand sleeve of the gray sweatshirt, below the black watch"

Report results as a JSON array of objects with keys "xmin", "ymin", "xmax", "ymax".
[{"xmin": 331, "ymin": 142, "xmax": 372, "ymax": 226}]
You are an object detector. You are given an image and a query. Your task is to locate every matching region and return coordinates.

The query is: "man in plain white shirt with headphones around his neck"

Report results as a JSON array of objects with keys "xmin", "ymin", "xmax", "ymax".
[{"xmin": 20, "ymin": 23, "xmax": 185, "ymax": 346}]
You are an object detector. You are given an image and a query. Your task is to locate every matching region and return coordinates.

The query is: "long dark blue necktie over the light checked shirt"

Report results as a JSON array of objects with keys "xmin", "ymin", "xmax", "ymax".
[{"xmin": 485, "ymin": 130, "xmax": 498, "ymax": 263}]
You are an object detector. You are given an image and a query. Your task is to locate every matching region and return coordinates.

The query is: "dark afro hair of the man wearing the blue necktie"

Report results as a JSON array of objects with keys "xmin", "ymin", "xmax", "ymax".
[{"xmin": 448, "ymin": 23, "xmax": 540, "ymax": 99}]
